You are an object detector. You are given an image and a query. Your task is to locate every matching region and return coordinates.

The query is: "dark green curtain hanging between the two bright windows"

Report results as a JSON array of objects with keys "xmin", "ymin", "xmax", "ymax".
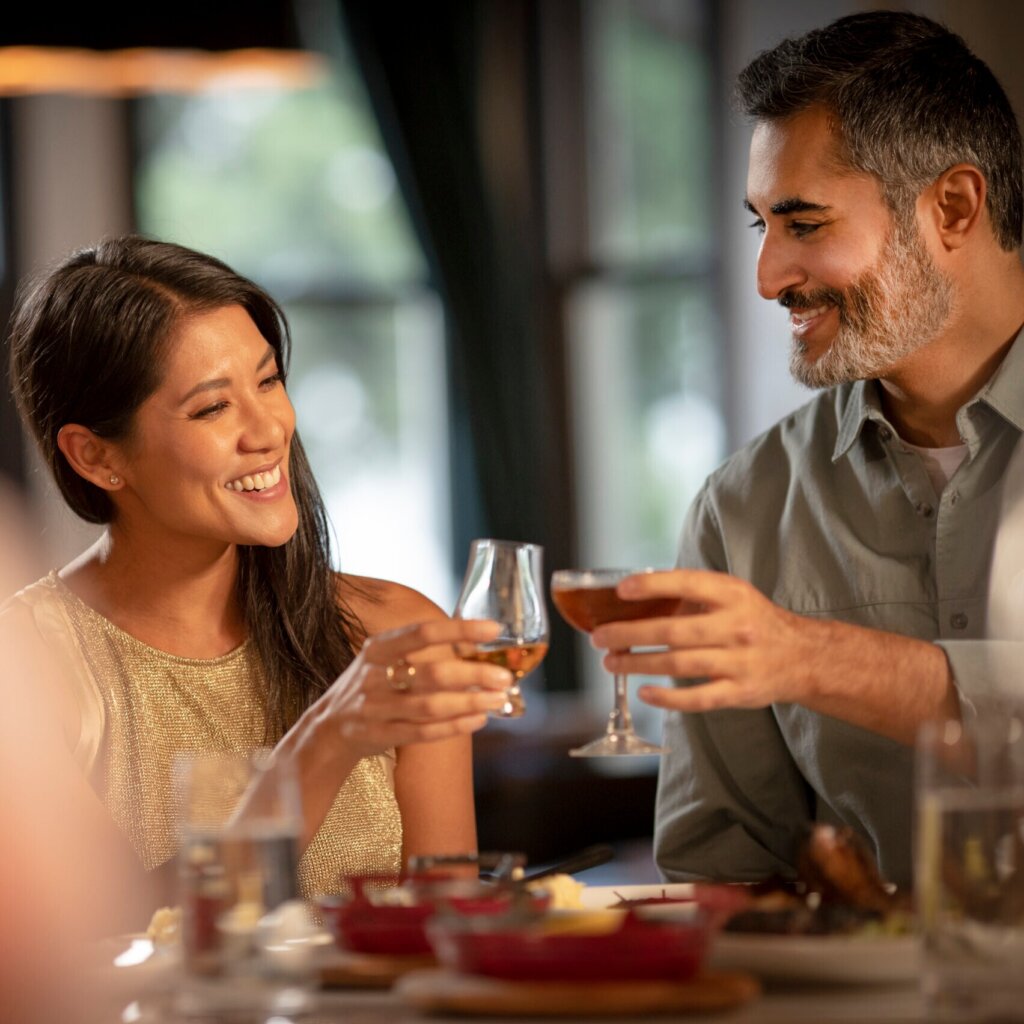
[{"xmin": 341, "ymin": 0, "xmax": 574, "ymax": 689}]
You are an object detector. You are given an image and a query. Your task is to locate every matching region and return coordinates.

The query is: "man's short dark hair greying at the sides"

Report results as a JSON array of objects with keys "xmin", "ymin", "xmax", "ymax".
[{"xmin": 736, "ymin": 10, "xmax": 1024, "ymax": 251}]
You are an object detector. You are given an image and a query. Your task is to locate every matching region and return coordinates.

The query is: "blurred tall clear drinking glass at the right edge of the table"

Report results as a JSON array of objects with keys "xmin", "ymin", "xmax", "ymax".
[{"xmin": 914, "ymin": 710, "xmax": 1024, "ymax": 1021}]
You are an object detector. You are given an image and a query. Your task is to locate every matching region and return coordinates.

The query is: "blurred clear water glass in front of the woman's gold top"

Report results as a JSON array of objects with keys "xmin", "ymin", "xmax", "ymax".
[{"xmin": 175, "ymin": 751, "xmax": 314, "ymax": 1017}]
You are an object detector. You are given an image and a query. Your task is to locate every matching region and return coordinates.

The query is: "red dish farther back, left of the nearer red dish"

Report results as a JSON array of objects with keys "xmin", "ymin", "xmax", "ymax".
[{"xmin": 318, "ymin": 878, "xmax": 550, "ymax": 956}]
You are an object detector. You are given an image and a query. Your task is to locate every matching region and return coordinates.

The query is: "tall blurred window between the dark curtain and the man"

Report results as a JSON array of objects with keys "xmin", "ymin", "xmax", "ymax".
[{"xmin": 549, "ymin": 0, "xmax": 727, "ymax": 734}]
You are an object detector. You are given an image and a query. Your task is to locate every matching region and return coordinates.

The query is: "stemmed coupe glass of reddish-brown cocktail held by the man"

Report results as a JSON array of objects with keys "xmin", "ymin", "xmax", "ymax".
[{"xmin": 551, "ymin": 569, "xmax": 679, "ymax": 758}]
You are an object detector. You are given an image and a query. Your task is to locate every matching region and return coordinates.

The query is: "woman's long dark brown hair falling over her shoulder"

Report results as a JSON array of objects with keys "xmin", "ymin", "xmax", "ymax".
[{"xmin": 10, "ymin": 236, "xmax": 365, "ymax": 741}]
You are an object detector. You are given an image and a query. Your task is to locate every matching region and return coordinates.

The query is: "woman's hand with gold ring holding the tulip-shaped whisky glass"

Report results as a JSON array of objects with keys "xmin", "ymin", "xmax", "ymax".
[{"xmin": 310, "ymin": 618, "xmax": 513, "ymax": 757}]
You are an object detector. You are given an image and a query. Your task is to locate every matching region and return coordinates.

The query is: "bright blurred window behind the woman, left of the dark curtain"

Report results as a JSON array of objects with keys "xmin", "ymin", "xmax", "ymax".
[{"xmin": 136, "ymin": 54, "xmax": 455, "ymax": 607}]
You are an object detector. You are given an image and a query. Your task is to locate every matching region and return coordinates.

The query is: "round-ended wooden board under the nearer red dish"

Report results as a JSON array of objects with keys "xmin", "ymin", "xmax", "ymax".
[{"xmin": 394, "ymin": 970, "xmax": 761, "ymax": 1017}]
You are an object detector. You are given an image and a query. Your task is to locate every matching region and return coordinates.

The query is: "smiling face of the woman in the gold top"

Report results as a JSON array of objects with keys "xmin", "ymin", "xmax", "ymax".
[{"xmin": 116, "ymin": 306, "xmax": 298, "ymax": 547}]
